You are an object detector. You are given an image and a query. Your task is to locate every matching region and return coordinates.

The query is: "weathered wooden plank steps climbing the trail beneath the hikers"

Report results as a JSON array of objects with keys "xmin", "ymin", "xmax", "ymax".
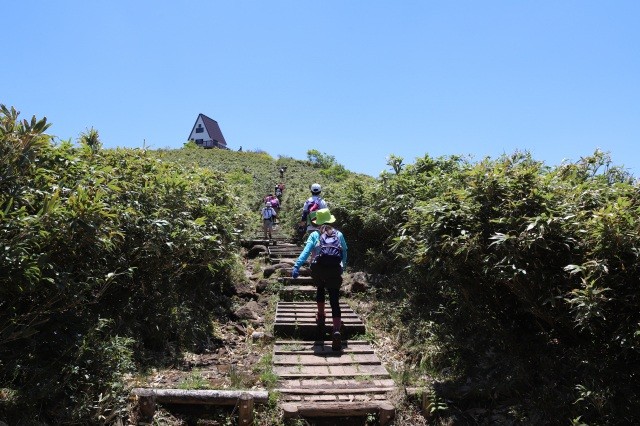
[{"xmin": 268, "ymin": 243, "xmax": 395, "ymax": 425}]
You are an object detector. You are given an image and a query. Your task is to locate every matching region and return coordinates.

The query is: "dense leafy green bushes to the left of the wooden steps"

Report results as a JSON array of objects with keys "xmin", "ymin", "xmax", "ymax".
[{"xmin": 0, "ymin": 106, "xmax": 242, "ymax": 422}]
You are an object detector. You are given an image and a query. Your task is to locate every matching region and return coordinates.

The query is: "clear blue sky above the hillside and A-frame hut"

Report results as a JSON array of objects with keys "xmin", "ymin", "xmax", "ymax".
[{"xmin": 6, "ymin": 0, "xmax": 640, "ymax": 176}]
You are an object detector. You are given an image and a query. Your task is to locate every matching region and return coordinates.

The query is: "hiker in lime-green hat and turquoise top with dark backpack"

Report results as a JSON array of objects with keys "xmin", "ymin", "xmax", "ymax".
[{"xmin": 291, "ymin": 208, "xmax": 347, "ymax": 351}]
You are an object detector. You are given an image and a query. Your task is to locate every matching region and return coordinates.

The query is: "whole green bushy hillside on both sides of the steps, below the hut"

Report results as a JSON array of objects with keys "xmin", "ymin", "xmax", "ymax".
[{"xmin": 0, "ymin": 106, "xmax": 640, "ymax": 425}]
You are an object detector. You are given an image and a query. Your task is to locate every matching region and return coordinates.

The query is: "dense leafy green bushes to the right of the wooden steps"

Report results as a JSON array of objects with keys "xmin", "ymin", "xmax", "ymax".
[{"xmin": 337, "ymin": 152, "xmax": 640, "ymax": 424}]
